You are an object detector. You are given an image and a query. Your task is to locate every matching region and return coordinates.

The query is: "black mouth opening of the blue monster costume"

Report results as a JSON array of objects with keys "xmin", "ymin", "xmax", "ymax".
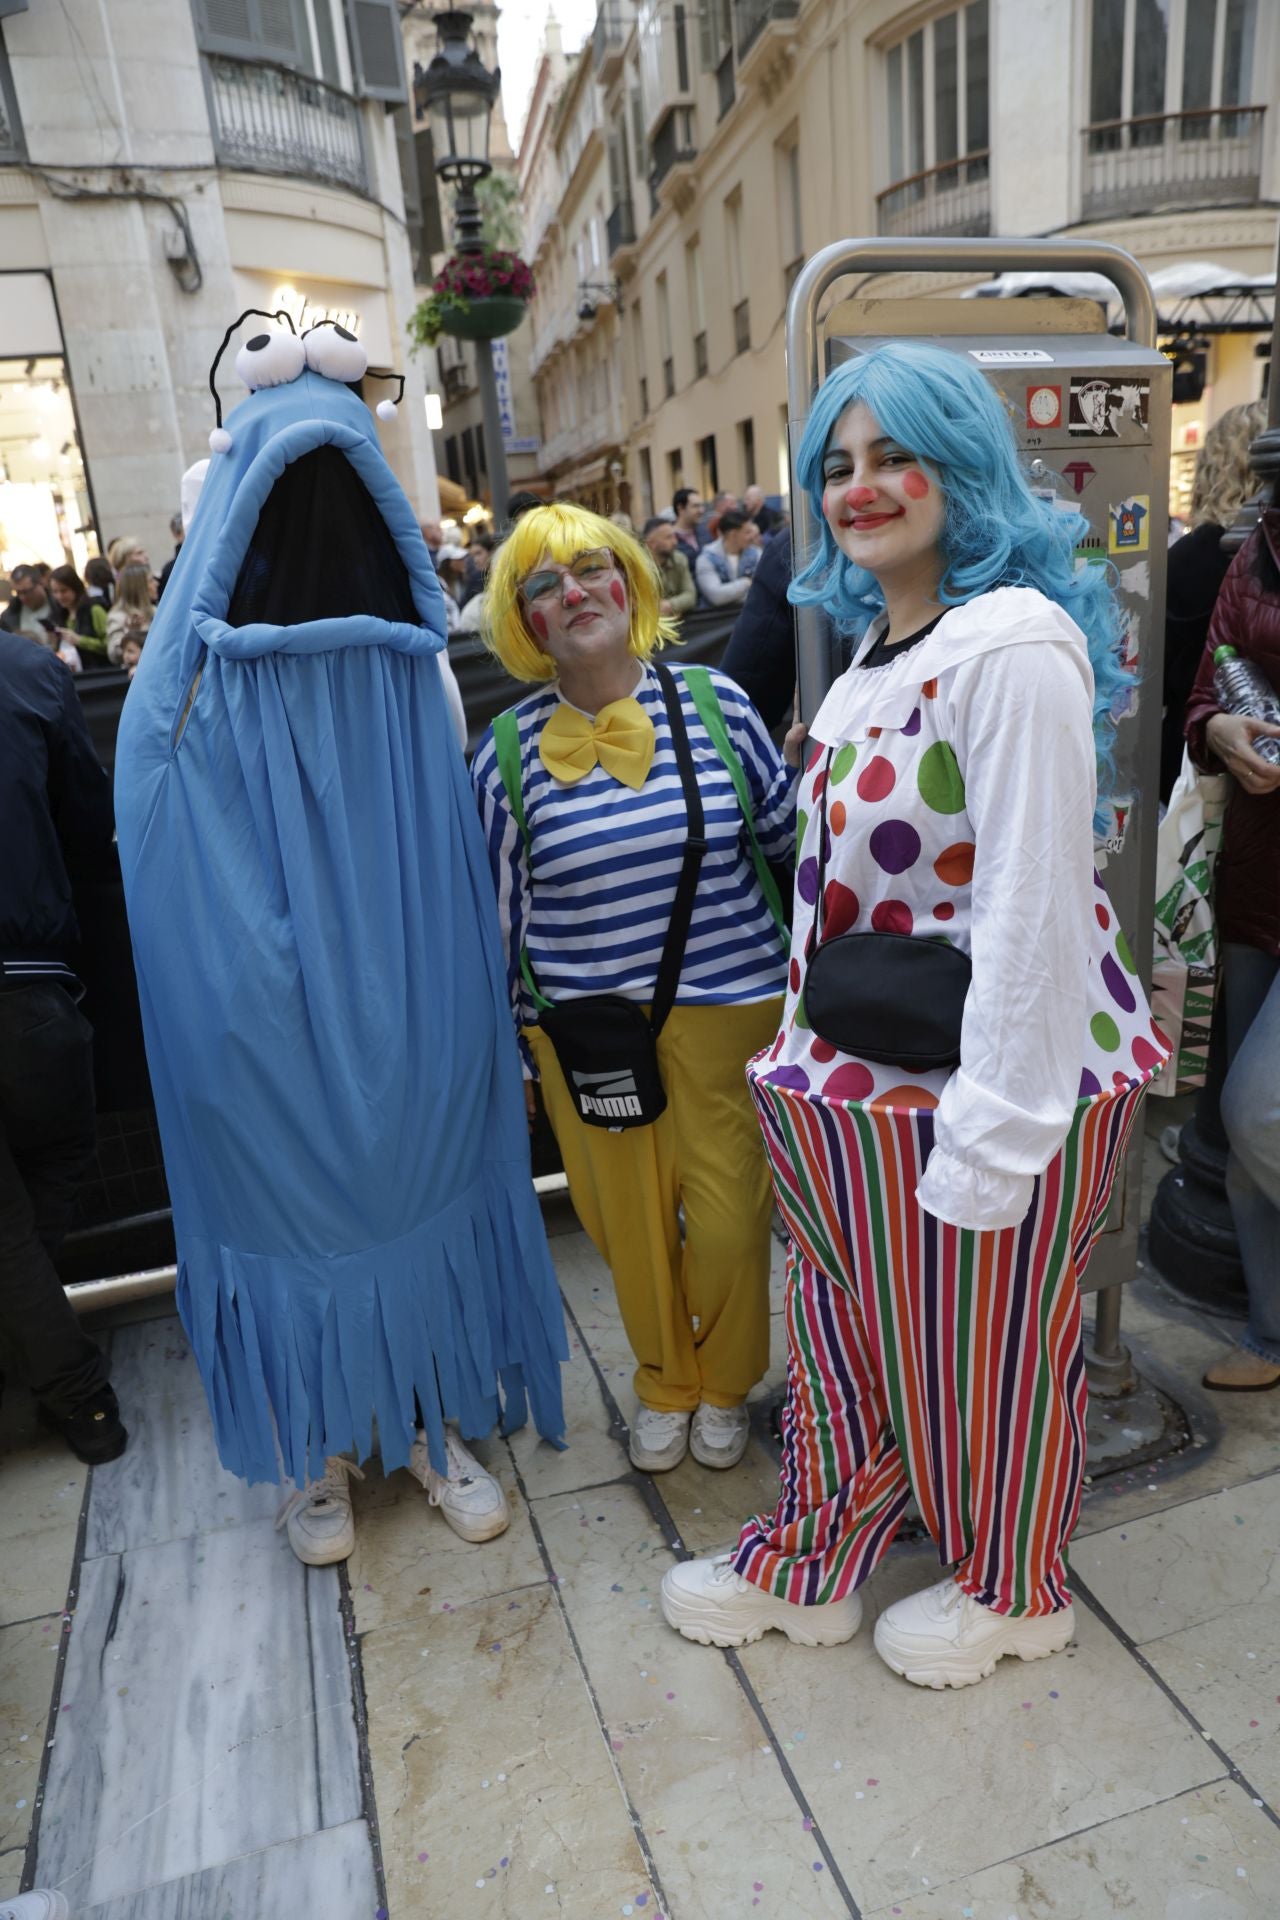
[{"xmin": 226, "ymin": 445, "xmax": 422, "ymax": 626}]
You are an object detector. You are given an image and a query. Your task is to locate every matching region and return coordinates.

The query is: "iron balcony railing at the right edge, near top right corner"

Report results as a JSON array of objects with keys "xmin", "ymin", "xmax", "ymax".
[{"xmin": 1080, "ymin": 108, "xmax": 1267, "ymax": 221}]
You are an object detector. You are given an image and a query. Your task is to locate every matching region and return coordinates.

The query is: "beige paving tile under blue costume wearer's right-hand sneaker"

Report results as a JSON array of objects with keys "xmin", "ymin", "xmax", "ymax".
[{"xmin": 347, "ymin": 1440, "xmax": 547, "ymax": 1634}]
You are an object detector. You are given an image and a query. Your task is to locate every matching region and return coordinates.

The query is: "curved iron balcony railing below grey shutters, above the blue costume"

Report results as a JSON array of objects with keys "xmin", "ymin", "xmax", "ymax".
[{"xmin": 203, "ymin": 54, "xmax": 368, "ymax": 194}]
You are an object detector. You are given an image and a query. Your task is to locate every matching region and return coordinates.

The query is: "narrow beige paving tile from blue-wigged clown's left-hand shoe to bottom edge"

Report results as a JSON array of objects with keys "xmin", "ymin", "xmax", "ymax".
[{"xmin": 537, "ymin": 1475, "xmax": 846, "ymax": 1920}]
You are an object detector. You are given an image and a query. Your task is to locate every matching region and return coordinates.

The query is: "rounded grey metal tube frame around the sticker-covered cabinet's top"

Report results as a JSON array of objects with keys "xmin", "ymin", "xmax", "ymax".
[{"xmin": 787, "ymin": 236, "xmax": 1157, "ymax": 720}]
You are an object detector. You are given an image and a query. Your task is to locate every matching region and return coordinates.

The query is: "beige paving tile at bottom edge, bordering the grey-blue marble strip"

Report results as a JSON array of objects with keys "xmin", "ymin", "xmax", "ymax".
[{"xmin": 363, "ymin": 1586, "xmax": 658, "ymax": 1920}]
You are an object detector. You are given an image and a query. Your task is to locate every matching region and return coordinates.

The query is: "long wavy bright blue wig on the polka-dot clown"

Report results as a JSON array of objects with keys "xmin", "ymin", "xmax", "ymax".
[{"xmin": 789, "ymin": 342, "xmax": 1132, "ymax": 801}]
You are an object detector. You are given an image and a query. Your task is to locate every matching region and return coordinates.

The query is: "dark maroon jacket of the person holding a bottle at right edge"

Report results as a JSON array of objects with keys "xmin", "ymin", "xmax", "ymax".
[{"xmin": 1186, "ymin": 507, "xmax": 1280, "ymax": 958}]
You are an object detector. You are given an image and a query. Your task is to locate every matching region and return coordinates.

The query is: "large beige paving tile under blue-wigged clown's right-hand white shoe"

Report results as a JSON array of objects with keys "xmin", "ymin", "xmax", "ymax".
[{"xmin": 729, "ymin": 1546, "xmax": 1222, "ymax": 1920}]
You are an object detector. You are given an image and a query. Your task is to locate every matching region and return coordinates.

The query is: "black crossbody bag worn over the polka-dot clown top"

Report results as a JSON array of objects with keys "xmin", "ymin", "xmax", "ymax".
[{"xmin": 804, "ymin": 747, "xmax": 973, "ymax": 1073}]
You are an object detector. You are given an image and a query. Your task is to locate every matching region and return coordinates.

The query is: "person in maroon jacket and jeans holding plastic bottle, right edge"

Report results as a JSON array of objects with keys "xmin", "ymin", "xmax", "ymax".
[{"xmin": 1186, "ymin": 507, "xmax": 1280, "ymax": 1394}]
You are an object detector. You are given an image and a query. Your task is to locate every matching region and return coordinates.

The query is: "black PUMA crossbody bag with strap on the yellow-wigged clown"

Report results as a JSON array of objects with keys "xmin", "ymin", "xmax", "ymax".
[{"xmin": 520, "ymin": 662, "xmax": 706, "ymax": 1133}]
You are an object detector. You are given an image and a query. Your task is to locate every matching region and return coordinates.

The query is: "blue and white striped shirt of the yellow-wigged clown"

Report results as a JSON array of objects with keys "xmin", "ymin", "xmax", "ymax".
[{"xmin": 472, "ymin": 666, "xmax": 796, "ymax": 1025}]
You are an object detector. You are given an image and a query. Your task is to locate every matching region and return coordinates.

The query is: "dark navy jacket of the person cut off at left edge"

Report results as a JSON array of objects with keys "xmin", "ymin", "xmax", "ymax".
[{"xmin": 0, "ymin": 632, "xmax": 111, "ymax": 968}]
